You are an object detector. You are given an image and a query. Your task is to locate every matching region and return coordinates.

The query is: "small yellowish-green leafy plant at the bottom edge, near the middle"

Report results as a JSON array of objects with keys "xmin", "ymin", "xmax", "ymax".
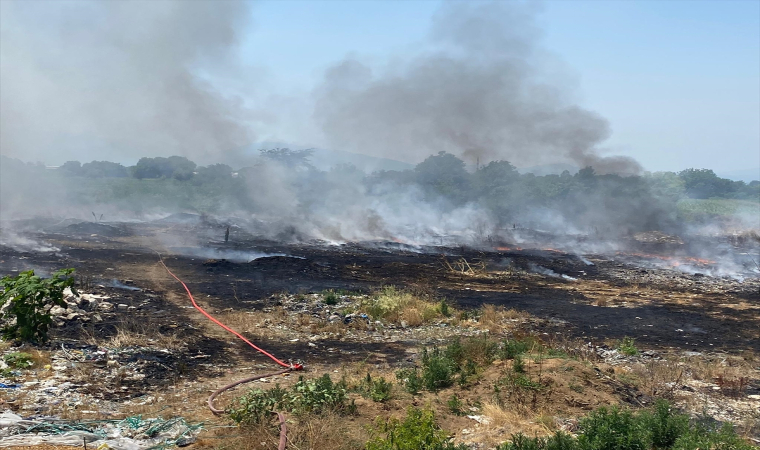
[{"xmin": 365, "ymin": 408, "xmax": 467, "ymax": 450}]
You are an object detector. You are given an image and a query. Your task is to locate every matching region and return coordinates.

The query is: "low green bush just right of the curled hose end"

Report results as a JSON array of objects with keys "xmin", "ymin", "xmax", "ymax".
[{"xmin": 227, "ymin": 374, "xmax": 356, "ymax": 423}]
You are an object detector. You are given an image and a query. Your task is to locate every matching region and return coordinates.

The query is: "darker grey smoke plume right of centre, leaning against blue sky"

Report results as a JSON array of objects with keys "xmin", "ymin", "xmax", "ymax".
[{"xmin": 314, "ymin": 2, "xmax": 641, "ymax": 174}]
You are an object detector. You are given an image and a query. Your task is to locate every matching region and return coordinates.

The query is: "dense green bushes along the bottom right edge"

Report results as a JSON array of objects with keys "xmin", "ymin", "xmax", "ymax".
[{"xmin": 497, "ymin": 401, "xmax": 758, "ymax": 450}]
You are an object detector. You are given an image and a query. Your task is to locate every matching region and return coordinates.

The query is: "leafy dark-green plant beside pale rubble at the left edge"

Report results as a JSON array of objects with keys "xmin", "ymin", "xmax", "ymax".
[{"xmin": 0, "ymin": 269, "xmax": 79, "ymax": 342}]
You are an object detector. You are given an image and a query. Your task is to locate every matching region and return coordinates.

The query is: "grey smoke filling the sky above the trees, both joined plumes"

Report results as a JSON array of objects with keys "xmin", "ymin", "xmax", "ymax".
[{"xmin": 0, "ymin": 0, "xmax": 640, "ymax": 174}]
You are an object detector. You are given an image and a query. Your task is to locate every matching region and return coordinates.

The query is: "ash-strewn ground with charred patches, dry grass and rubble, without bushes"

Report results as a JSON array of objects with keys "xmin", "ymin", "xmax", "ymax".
[{"xmin": 0, "ymin": 214, "xmax": 760, "ymax": 448}]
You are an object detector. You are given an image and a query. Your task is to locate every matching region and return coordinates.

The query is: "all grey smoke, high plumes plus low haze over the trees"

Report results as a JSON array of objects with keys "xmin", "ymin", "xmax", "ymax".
[{"xmin": 0, "ymin": 1, "xmax": 757, "ymax": 278}]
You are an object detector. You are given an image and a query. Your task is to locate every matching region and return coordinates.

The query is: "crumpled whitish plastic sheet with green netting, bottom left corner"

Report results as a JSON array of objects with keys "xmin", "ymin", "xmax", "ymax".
[{"xmin": 0, "ymin": 411, "xmax": 201, "ymax": 450}]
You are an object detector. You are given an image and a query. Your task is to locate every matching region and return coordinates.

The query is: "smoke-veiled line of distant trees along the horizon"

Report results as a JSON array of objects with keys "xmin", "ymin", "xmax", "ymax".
[{"xmin": 2, "ymin": 149, "xmax": 760, "ymax": 230}]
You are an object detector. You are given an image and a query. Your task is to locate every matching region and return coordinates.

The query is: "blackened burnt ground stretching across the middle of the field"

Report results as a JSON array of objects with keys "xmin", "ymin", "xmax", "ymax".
[{"xmin": 0, "ymin": 220, "xmax": 760, "ymax": 359}]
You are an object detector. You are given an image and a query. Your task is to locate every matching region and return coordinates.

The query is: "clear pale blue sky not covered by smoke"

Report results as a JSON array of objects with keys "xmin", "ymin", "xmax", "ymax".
[{"xmin": 241, "ymin": 0, "xmax": 760, "ymax": 172}]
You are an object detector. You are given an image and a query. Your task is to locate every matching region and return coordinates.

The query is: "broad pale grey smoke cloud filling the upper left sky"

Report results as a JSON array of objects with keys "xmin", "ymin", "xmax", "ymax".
[{"xmin": 0, "ymin": 0, "xmax": 253, "ymax": 163}]
